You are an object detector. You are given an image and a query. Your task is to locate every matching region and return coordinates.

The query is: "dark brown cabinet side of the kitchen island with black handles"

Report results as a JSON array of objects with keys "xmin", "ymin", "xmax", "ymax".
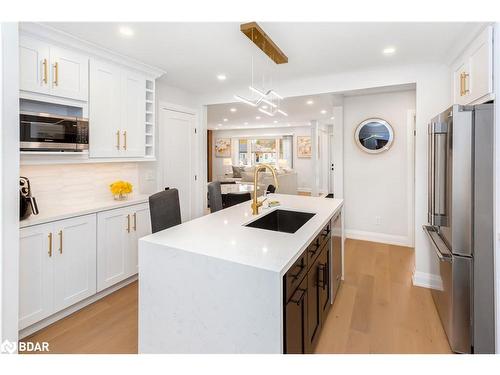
[{"xmin": 283, "ymin": 214, "xmax": 338, "ymax": 354}]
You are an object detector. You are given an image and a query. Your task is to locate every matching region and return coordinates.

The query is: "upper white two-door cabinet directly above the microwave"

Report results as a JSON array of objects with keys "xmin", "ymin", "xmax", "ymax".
[{"xmin": 19, "ymin": 36, "xmax": 89, "ymax": 102}]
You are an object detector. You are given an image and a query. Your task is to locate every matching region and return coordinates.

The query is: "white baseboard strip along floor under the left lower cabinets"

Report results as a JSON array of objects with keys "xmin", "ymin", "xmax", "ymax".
[{"xmin": 19, "ymin": 275, "xmax": 138, "ymax": 339}]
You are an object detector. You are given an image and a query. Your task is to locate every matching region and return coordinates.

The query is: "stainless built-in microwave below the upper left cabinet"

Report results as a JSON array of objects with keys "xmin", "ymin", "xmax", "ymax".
[{"xmin": 19, "ymin": 112, "xmax": 89, "ymax": 152}]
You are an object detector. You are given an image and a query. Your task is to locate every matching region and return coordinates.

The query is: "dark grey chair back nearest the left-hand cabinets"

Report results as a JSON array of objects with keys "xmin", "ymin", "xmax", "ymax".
[{"xmin": 149, "ymin": 189, "xmax": 182, "ymax": 233}]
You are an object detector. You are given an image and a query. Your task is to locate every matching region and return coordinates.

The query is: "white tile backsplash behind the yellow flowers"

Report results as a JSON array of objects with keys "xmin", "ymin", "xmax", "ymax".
[{"xmin": 20, "ymin": 163, "xmax": 140, "ymax": 210}]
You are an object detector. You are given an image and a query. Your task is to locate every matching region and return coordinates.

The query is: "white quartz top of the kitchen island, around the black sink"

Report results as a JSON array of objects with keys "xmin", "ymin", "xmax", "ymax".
[{"xmin": 140, "ymin": 194, "xmax": 343, "ymax": 274}]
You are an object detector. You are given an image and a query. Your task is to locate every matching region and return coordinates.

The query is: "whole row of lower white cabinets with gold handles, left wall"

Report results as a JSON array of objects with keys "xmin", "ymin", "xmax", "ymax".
[{"xmin": 19, "ymin": 203, "xmax": 151, "ymax": 329}]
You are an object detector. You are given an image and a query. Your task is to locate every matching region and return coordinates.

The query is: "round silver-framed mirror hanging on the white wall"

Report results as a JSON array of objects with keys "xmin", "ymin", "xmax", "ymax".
[{"xmin": 354, "ymin": 118, "xmax": 394, "ymax": 154}]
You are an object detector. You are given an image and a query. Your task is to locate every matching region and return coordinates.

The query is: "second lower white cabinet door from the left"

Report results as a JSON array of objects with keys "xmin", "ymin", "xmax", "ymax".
[{"xmin": 54, "ymin": 215, "xmax": 96, "ymax": 311}]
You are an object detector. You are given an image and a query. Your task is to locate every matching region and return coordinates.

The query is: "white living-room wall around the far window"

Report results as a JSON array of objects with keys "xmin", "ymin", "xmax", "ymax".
[{"xmin": 212, "ymin": 126, "xmax": 313, "ymax": 192}]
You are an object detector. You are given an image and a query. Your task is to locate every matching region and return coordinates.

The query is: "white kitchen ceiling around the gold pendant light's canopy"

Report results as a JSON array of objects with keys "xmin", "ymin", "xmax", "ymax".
[{"xmin": 45, "ymin": 22, "xmax": 480, "ymax": 94}]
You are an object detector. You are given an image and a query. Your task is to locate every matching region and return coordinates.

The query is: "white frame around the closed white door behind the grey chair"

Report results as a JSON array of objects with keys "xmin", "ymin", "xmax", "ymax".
[{"xmin": 159, "ymin": 100, "xmax": 200, "ymax": 220}]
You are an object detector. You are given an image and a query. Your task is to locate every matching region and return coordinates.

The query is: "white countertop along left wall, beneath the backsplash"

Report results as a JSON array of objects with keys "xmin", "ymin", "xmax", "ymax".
[{"xmin": 19, "ymin": 194, "xmax": 149, "ymax": 228}]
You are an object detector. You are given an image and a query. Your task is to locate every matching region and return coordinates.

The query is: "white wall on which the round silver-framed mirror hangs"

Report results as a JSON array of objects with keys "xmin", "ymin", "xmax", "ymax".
[{"xmin": 344, "ymin": 91, "xmax": 415, "ymax": 246}]
